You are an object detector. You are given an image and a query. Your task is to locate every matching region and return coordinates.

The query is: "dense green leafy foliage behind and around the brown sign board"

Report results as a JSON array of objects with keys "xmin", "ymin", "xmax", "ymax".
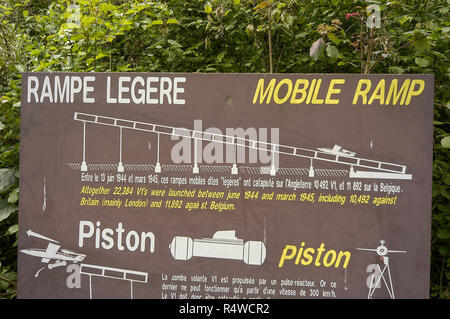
[{"xmin": 0, "ymin": 0, "xmax": 450, "ymax": 298}]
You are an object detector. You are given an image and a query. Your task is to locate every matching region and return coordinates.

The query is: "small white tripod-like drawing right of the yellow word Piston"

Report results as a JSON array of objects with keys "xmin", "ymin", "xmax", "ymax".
[{"xmin": 356, "ymin": 240, "xmax": 406, "ymax": 299}]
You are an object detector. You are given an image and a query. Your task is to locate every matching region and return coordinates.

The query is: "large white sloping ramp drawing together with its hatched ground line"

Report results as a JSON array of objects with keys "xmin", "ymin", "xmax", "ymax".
[{"xmin": 69, "ymin": 112, "xmax": 412, "ymax": 180}]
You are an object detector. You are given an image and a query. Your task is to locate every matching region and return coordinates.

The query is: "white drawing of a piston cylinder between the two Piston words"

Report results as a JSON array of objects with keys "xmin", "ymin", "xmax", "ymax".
[{"xmin": 169, "ymin": 230, "xmax": 266, "ymax": 266}]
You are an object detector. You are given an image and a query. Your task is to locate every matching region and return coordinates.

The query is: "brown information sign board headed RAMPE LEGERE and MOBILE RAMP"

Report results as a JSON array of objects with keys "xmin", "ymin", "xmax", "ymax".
[{"xmin": 18, "ymin": 73, "xmax": 433, "ymax": 299}]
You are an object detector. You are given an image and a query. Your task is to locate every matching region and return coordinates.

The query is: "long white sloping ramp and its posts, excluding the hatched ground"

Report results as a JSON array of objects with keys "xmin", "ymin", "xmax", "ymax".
[{"xmin": 74, "ymin": 112, "xmax": 412, "ymax": 180}]
